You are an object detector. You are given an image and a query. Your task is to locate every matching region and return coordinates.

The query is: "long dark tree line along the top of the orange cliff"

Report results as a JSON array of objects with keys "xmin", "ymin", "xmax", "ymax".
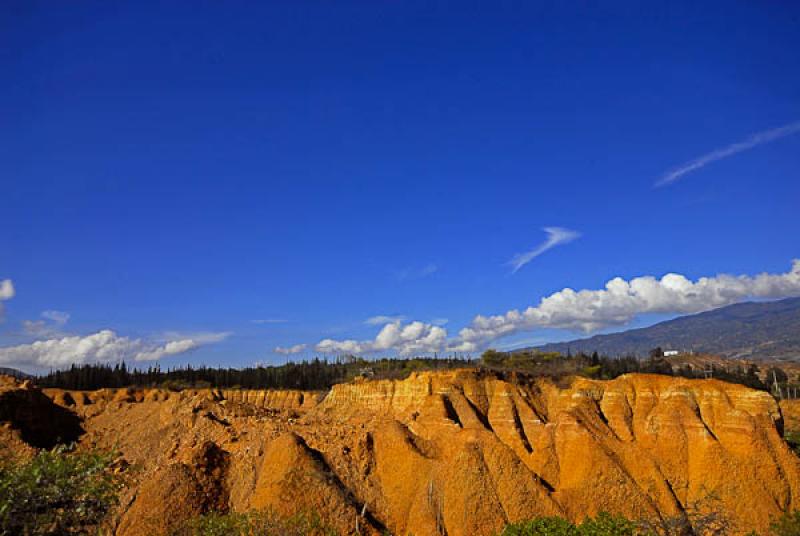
[{"xmin": 37, "ymin": 349, "xmax": 780, "ymax": 395}]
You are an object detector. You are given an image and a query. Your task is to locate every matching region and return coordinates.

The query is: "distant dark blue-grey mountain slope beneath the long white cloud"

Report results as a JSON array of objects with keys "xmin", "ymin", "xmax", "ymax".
[{"xmin": 536, "ymin": 298, "xmax": 800, "ymax": 359}]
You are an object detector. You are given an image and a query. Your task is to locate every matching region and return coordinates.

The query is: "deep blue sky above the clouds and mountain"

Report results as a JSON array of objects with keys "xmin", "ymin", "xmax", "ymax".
[{"xmin": 0, "ymin": 1, "xmax": 800, "ymax": 366}]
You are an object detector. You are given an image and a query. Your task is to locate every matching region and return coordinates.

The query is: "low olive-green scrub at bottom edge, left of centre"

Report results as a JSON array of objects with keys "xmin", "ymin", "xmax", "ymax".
[{"xmin": 174, "ymin": 510, "xmax": 337, "ymax": 536}]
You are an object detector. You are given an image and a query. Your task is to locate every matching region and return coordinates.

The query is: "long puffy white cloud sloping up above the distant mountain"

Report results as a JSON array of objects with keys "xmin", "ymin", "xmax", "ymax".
[{"xmin": 451, "ymin": 260, "xmax": 800, "ymax": 351}]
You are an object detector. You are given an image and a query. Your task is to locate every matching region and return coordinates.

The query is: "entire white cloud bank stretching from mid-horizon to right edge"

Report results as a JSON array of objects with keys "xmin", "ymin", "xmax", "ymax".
[{"xmin": 276, "ymin": 259, "xmax": 800, "ymax": 355}]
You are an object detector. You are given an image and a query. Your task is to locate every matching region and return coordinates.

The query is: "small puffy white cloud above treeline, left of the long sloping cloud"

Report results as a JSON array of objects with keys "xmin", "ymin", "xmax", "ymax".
[{"xmin": 316, "ymin": 320, "xmax": 447, "ymax": 355}]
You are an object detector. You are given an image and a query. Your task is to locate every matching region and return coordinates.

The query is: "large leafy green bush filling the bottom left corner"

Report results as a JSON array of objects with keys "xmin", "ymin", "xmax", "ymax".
[{"xmin": 0, "ymin": 446, "xmax": 120, "ymax": 536}]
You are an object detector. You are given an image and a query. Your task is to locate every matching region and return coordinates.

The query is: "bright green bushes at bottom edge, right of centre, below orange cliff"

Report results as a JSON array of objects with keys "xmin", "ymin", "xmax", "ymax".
[{"xmin": 501, "ymin": 513, "xmax": 650, "ymax": 536}]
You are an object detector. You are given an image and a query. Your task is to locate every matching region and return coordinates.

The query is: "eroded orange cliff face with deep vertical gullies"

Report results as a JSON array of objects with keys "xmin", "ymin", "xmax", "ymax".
[{"xmin": 10, "ymin": 370, "xmax": 800, "ymax": 535}]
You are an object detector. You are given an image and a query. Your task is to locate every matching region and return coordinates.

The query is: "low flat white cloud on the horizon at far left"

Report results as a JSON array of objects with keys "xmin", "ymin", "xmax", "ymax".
[{"xmin": 0, "ymin": 329, "xmax": 229, "ymax": 368}]
